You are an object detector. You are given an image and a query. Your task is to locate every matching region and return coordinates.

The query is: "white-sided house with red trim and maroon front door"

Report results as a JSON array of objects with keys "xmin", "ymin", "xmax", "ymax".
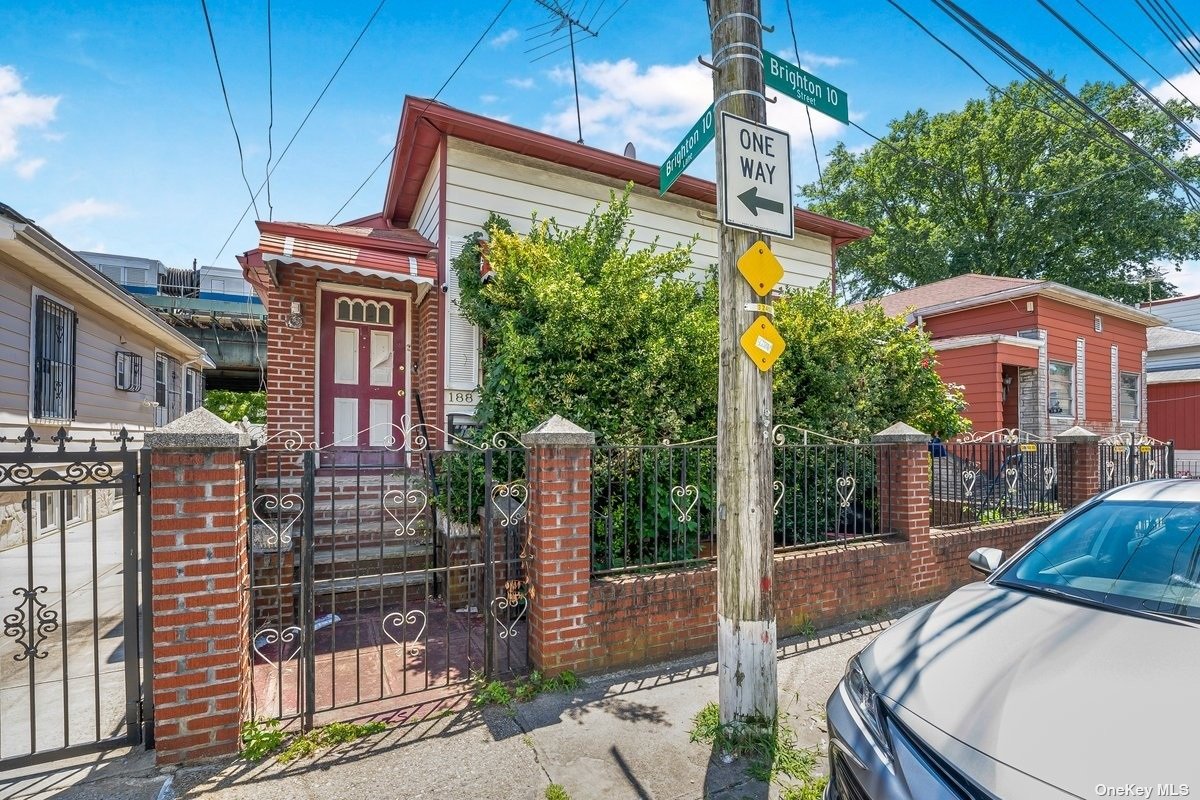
[{"xmin": 239, "ymin": 97, "xmax": 870, "ymax": 447}]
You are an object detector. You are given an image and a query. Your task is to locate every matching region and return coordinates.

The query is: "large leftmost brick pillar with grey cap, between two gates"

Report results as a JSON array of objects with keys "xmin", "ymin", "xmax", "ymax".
[{"xmin": 146, "ymin": 408, "xmax": 251, "ymax": 764}]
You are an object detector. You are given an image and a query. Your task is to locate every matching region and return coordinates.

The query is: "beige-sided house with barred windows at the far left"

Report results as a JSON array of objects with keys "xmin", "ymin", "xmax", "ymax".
[{"xmin": 0, "ymin": 203, "xmax": 211, "ymax": 549}]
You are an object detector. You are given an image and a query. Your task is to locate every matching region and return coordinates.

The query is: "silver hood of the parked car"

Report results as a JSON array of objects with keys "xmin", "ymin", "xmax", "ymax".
[{"xmin": 860, "ymin": 583, "xmax": 1200, "ymax": 798}]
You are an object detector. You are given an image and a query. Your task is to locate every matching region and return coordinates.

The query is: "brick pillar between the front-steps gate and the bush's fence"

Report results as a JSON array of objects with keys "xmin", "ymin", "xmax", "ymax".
[{"xmin": 521, "ymin": 415, "xmax": 595, "ymax": 675}]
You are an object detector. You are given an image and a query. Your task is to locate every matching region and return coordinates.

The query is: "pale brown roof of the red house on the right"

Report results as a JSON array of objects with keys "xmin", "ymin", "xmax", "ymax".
[{"xmin": 854, "ymin": 272, "xmax": 1164, "ymax": 327}]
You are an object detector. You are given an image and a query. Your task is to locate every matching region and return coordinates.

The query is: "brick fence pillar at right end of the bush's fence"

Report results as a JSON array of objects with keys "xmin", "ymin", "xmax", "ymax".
[{"xmin": 871, "ymin": 422, "xmax": 938, "ymax": 599}]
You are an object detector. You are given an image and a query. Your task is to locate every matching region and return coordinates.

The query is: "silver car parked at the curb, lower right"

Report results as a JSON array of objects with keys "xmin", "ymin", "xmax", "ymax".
[{"xmin": 826, "ymin": 480, "xmax": 1200, "ymax": 800}]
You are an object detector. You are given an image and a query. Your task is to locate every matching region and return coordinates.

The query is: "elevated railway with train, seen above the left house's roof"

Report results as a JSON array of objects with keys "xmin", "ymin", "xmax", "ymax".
[{"xmin": 77, "ymin": 251, "xmax": 266, "ymax": 391}]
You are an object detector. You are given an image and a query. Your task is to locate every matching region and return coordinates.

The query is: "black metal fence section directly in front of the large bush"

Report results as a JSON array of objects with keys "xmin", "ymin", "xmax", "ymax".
[{"xmin": 592, "ymin": 434, "xmax": 890, "ymax": 576}]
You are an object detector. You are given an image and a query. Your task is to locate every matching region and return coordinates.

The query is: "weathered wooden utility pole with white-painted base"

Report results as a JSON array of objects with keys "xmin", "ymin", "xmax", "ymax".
[{"xmin": 708, "ymin": 0, "xmax": 778, "ymax": 723}]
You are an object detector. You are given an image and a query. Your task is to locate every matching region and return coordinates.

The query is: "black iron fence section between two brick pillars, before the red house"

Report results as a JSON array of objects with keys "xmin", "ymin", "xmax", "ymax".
[{"xmin": 930, "ymin": 431, "xmax": 1069, "ymax": 528}]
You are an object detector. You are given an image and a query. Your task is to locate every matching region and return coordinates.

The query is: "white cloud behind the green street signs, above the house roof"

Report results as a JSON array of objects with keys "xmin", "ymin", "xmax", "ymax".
[{"xmin": 542, "ymin": 59, "xmax": 845, "ymax": 162}]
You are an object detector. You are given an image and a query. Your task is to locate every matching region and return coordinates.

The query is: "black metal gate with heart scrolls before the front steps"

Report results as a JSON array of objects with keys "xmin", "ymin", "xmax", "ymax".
[{"xmin": 246, "ymin": 431, "xmax": 533, "ymax": 727}]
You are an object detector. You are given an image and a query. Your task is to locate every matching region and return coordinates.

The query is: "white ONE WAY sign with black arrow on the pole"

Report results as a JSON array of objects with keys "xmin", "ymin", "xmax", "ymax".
[{"xmin": 721, "ymin": 112, "xmax": 796, "ymax": 239}]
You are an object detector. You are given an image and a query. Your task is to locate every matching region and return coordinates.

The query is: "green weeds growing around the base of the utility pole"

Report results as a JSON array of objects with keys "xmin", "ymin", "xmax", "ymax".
[{"xmin": 691, "ymin": 703, "xmax": 826, "ymax": 800}]
